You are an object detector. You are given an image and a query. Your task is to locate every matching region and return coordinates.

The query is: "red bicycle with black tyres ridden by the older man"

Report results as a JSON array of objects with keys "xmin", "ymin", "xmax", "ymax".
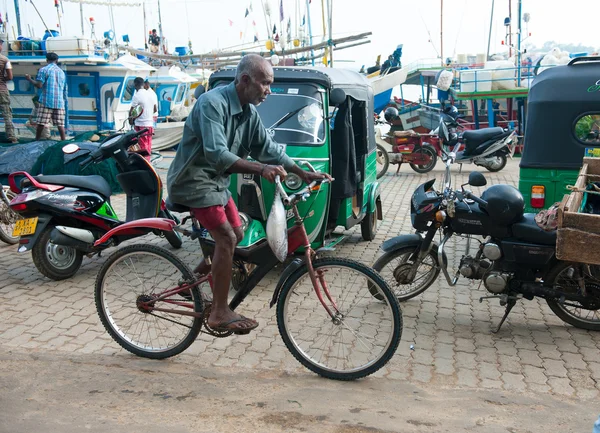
[{"xmin": 95, "ymin": 175, "xmax": 402, "ymax": 380}]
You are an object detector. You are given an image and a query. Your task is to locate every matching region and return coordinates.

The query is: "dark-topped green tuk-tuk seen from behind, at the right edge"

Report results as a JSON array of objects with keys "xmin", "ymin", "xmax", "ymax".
[{"xmin": 519, "ymin": 57, "xmax": 600, "ymax": 212}]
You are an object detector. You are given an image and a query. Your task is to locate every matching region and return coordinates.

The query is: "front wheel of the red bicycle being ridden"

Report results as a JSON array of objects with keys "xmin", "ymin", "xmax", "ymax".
[{"xmin": 277, "ymin": 258, "xmax": 402, "ymax": 380}]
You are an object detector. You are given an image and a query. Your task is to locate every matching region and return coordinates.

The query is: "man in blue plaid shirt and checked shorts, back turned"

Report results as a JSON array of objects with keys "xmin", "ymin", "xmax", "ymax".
[{"xmin": 25, "ymin": 53, "xmax": 67, "ymax": 141}]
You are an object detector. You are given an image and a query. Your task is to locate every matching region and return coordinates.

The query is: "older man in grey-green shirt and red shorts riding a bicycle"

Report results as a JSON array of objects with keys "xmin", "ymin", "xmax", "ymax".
[{"xmin": 167, "ymin": 54, "xmax": 329, "ymax": 334}]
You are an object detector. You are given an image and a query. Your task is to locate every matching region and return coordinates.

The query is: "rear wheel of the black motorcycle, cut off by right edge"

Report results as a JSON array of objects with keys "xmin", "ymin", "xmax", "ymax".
[{"xmin": 545, "ymin": 262, "xmax": 600, "ymax": 331}]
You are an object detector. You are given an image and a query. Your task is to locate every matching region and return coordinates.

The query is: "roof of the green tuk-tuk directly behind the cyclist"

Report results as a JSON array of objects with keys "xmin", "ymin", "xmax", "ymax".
[{"xmin": 209, "ymin": 66, "xmax": 373, "ymax": 105}]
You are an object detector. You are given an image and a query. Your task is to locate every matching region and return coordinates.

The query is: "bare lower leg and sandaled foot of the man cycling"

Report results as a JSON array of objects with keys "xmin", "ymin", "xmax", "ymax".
[{"xmin": 208, "ymin": 222, "xmax": 257, "ymax": 329}]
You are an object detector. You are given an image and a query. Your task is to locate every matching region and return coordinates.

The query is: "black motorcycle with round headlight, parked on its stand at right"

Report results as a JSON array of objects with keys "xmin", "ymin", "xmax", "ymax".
[{"xmin": 373, "ymin": 144, "xmax": 600, "ymax": 332}]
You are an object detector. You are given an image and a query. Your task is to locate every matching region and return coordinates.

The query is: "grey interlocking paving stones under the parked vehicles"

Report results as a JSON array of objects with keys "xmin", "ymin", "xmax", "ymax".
[{"xmin": 0, "ymin": 158, "xmax": 600, "ymax": 399}]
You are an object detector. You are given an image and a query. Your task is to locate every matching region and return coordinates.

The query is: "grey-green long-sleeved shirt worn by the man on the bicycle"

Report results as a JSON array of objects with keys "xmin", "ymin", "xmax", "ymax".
[{"xmin": 167, "ymin": 83, "xmax": 294, "ymax": 208}]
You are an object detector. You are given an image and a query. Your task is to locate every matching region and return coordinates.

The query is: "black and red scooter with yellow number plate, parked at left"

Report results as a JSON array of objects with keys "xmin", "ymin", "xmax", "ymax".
[{"xmin": 8, "ymin": 125, "xmax": 182, "ymax": 280}]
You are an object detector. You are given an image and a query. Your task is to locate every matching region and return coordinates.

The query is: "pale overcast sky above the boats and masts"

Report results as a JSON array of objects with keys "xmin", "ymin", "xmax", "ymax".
[{"xmin": 0, "ymin": 0, "xmax": 600, "ymax": 68}]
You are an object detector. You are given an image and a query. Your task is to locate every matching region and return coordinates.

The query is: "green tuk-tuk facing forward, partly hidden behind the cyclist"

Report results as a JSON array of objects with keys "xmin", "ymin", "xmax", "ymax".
[{"xmin": 209, "ymin": 67, "xmax": 383, "ymax": 249}]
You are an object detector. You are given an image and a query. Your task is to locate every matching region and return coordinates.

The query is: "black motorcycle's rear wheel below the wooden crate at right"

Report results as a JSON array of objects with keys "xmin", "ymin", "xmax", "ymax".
[{"xmin": 545, "ymin": 262, "xmax": 600, "ymax": 331}]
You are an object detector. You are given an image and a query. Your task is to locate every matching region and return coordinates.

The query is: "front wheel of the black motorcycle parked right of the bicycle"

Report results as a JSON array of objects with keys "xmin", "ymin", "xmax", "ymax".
[{"xmin": 372, "ymin": 246, "xmax": 440, "ymax": 302}]
